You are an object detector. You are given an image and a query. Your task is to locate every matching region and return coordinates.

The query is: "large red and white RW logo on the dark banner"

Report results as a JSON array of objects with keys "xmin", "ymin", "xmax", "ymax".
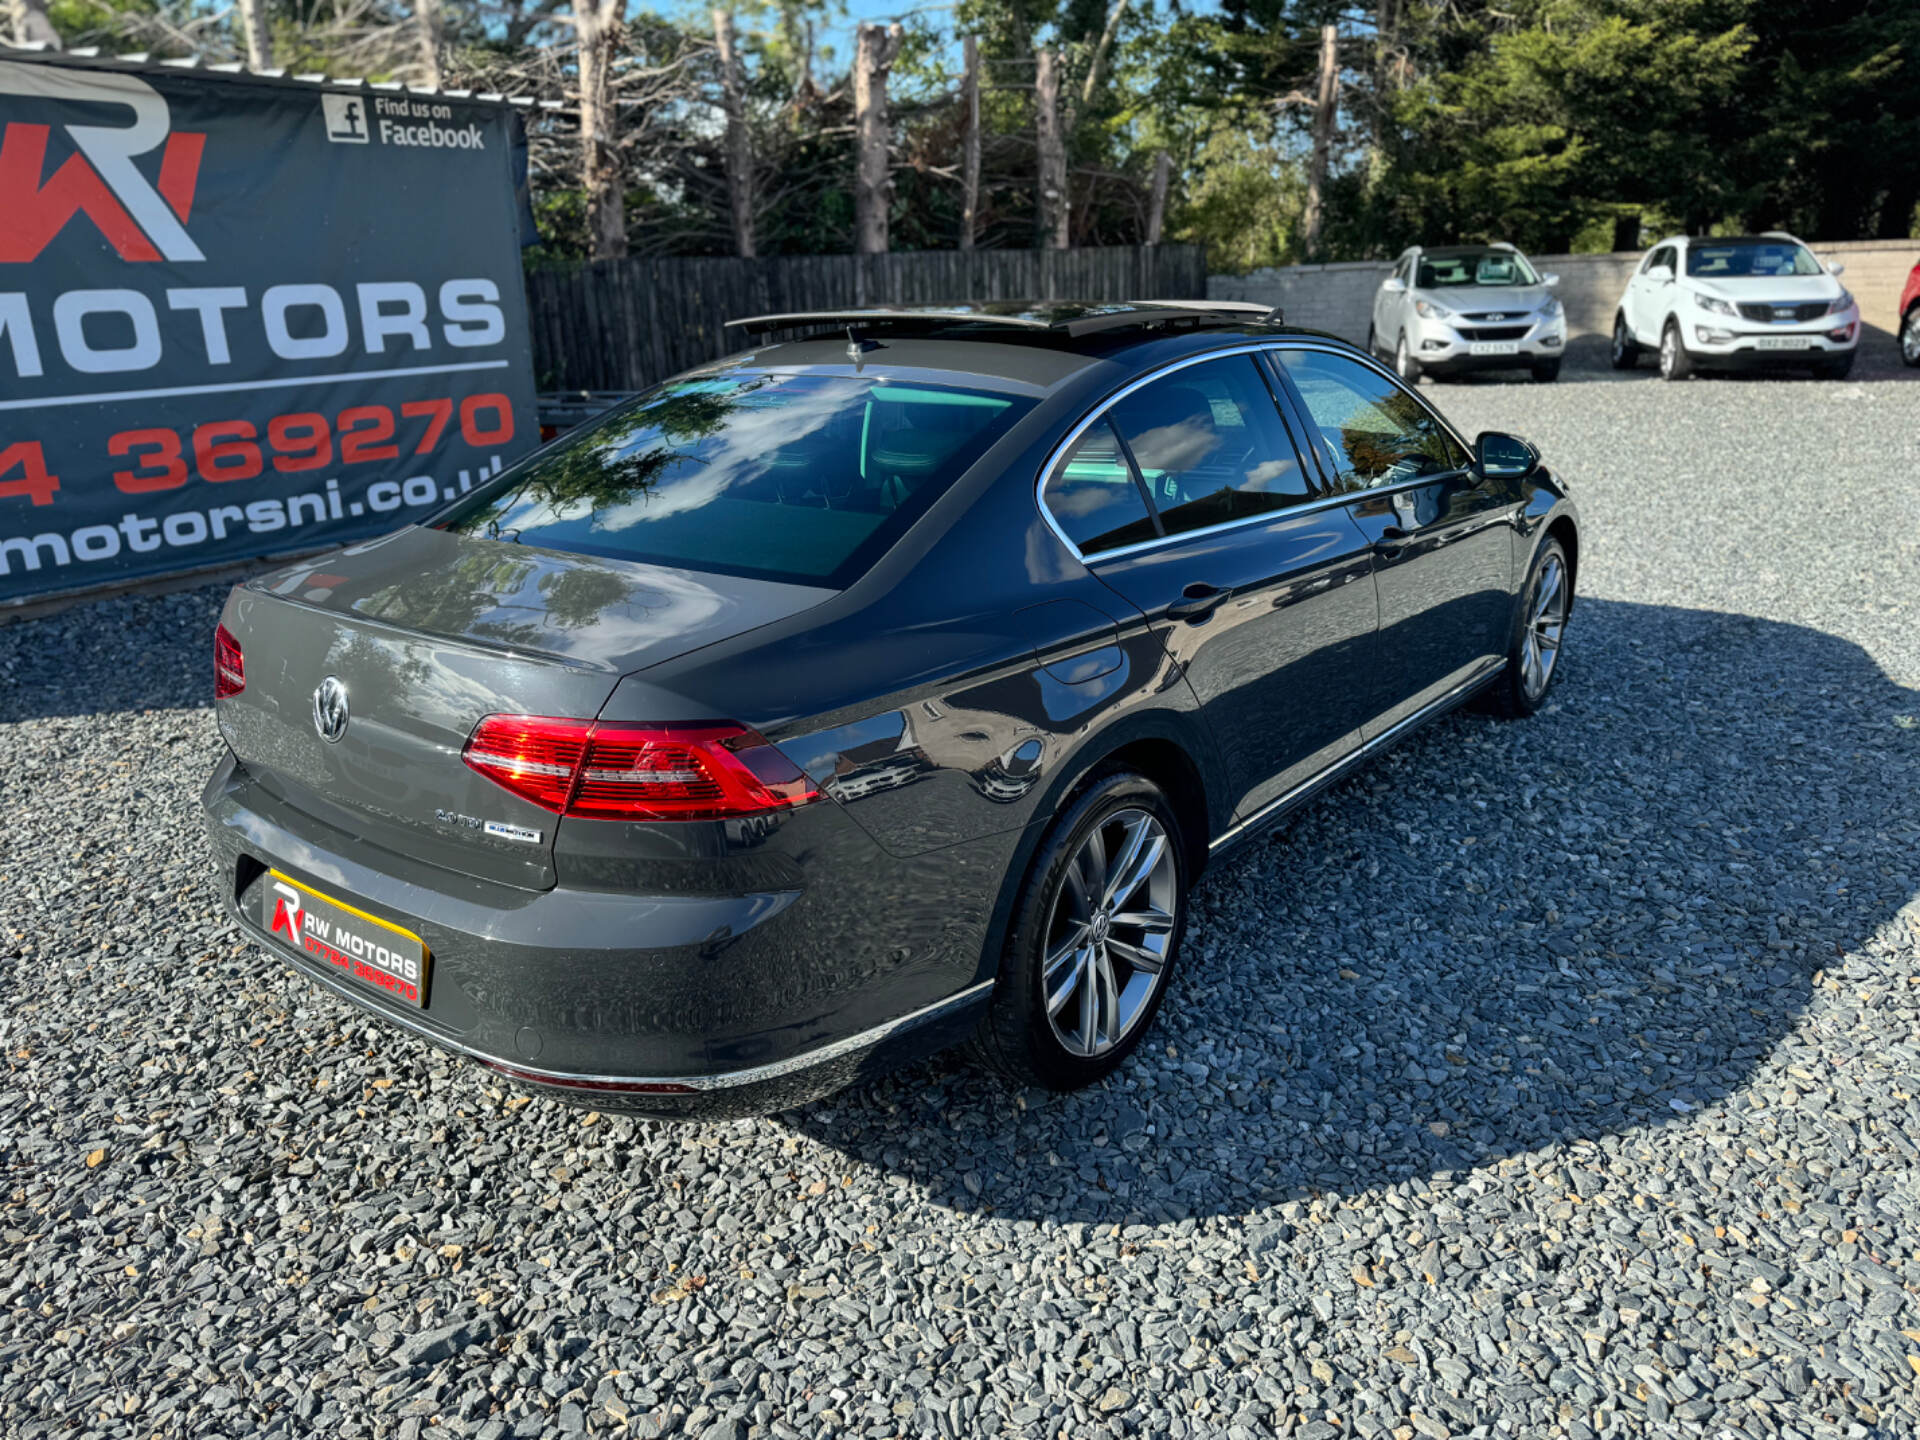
[{"xmin": 0, "ymin": 65, "xmax": 207, "ymax": 265}]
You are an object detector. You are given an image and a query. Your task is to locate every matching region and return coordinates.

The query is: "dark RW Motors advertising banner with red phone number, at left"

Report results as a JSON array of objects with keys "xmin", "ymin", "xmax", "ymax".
[{"xmin": 0, "ymin": 58, "xmax": 538, "ymax": 603}]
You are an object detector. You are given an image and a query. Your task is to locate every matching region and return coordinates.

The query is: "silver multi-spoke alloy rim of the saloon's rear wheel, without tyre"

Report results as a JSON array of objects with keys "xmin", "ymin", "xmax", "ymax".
[{"xmin": 1041, "ymin": 808, "xmax": 1179, "ymax": 1060}]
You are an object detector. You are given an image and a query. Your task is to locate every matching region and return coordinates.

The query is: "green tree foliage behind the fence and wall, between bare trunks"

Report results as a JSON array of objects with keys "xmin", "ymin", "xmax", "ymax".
[{"xmin": 33, "ymin": 0, "xmax": 1920, "ymax": 259}]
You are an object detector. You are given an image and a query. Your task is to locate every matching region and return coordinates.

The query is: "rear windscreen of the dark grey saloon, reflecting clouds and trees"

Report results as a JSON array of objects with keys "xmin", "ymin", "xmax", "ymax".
[{"xmin": 438, "ymin": 372, "xmax": 1033, "ymax": 586}]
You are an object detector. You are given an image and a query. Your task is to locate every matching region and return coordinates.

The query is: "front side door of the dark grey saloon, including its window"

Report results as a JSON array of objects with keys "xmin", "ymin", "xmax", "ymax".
[{"xmin": 1273, "ymin": 348, "xmax": 1521, "ymax": 739}]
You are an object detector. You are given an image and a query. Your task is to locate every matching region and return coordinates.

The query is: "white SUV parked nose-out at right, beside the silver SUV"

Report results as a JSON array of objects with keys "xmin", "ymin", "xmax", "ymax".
[{"xmin": 1613, "ymin": 230, "xmax": 1860, "ymax": 380}]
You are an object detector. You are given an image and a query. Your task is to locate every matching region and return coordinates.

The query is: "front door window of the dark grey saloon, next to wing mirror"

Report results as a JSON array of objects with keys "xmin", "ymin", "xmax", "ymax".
[{"xmin": 1279, "ymin": 349, "xmax": 1467, "ymax": 492}]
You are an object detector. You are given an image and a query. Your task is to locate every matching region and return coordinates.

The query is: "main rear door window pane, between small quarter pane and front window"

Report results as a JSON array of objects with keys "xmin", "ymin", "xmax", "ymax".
[{"xmin": 1110, "ymin": 355, "xmax": 1311, "ymax": 536}]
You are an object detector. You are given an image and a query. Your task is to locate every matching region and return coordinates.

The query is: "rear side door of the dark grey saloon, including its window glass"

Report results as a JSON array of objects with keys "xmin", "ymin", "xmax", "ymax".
[{"xmin": 1046, "ymin": 351, "xmax": 1375, "ymax": 816}]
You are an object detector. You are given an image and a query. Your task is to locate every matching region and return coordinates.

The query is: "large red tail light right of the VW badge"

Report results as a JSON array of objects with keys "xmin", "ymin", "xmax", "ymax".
[{"xmin": 463, "ymin": 714, "xmax": 820, "ymax": 820}]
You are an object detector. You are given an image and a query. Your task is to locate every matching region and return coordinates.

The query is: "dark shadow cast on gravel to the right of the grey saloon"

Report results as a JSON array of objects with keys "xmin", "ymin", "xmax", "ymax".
[{"xmin": 776, "ymin": 599, "xmax": 1920, "ymax": 1238}]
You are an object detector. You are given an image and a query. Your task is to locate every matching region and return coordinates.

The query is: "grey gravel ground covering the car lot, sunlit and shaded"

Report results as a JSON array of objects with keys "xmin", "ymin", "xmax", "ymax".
[{"xmin": 0, "ymin": 376, "xmax": 1920, "ymax": 1440}]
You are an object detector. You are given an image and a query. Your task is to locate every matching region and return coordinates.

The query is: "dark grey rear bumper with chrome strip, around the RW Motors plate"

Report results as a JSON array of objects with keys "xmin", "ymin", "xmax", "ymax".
[{"xmin": 204, "ymin": 756, "xmax": 991, "ymax": 1119}]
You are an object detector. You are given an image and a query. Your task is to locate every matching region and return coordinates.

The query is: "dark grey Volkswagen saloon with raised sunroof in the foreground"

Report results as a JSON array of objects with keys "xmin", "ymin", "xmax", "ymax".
[{"xmin": 205, "ymin": 303, "xmax": 1580, "ymax": 1116}]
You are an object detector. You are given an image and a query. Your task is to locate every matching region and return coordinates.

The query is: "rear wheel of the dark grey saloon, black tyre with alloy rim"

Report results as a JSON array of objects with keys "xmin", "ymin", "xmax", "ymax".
[{"xmin": 973, "ymin": 770, "xmax": 1187, "ymax": 1091}]
